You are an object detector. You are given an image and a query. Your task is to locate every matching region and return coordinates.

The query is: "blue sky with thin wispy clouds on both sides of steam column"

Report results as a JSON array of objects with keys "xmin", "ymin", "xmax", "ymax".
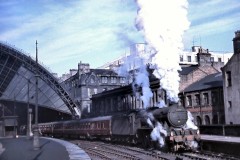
[{"xmin": 0, "ymin": 0, "xmax": 240, "ymax": 76}]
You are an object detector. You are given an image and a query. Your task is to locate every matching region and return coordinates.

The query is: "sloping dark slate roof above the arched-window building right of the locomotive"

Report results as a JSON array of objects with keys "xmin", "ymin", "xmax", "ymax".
[{"xmin": 183, "ymin": 72, "xmax": 223, "ymax": 92}]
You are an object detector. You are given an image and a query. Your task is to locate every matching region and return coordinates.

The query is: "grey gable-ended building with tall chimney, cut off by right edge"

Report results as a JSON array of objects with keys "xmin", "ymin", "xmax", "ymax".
[{"xmin": 222, "ymin": 30, "xmax": 240, "ymax": 124}]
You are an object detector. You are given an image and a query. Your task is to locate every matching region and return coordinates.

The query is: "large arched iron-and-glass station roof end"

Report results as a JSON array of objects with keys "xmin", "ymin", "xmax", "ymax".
[{"xmin": 0, "ymin": 42, "xmax": 80, "ymax": 117}]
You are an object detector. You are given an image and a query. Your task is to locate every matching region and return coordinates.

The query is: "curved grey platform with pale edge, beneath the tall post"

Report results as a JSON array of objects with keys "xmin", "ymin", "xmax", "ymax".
[{"xmin": 0, "ymin": 137, "xmax": 91, "ymax": 160}]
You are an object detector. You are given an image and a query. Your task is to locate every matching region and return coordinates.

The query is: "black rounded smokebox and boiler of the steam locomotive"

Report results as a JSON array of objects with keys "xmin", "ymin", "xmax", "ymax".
[{"xmin": 152, "ymin": 104, "xmax": 188, "ymax": 128}]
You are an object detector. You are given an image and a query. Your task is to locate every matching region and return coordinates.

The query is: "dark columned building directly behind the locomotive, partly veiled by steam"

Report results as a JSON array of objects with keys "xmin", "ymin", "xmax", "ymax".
[{"xmin": 91, "ymin": 78, "xmax": 168, "ymax": 117}]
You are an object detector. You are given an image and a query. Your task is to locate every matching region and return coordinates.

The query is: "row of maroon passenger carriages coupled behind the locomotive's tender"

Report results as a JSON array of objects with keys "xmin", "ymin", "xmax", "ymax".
[{"xmin": 39, "ymin": 116, "xmax": 112, "ymax": 140}]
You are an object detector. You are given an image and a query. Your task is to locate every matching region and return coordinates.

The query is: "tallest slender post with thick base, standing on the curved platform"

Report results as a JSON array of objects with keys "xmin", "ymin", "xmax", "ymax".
[{"xmin": 33, "ymin": 41, "xmax": 40, "ymax": 150}]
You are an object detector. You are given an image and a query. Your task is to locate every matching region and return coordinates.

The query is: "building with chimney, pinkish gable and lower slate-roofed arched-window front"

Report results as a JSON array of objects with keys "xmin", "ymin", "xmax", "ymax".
[{"xmin": 179, "ymin": 48, "xmax": 225, "ymax": 125}]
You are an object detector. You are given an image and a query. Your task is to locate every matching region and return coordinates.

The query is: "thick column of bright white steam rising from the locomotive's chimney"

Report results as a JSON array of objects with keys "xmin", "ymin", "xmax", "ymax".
[{"xmin": 136, "ymin": 0, "xmax": 190, "ymax": 102}]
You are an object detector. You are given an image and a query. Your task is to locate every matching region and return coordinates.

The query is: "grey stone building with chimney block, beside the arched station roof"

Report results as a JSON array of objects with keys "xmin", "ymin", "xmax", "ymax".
[{"xmin": 62, "ymin": 62, "xmax": 128, "ymax": 117}]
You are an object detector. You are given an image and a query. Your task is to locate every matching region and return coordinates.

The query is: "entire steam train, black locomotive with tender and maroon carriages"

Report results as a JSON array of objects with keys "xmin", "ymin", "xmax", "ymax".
[{"xmin": 39, "ymin": 104, "xmax": 200, "ymax": 151}]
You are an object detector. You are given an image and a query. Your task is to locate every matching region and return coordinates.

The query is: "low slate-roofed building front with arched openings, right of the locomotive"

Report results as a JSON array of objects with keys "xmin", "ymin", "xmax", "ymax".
[{"xmin": 179, "ymin": 72, "xmax": 225, "ymax": 125}]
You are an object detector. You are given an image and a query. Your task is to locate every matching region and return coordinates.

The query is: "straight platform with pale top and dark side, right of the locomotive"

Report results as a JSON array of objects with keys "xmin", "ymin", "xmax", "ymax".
[{"xmin": 201, "ymin": 135, "xmax": 240, "ymax": 158}]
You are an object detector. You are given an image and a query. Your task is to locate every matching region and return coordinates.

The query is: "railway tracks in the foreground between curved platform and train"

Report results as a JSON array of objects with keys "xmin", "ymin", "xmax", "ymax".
[{"xmin": 70, "ymin": 140, "xmax": 237, "ymax": 160}]
